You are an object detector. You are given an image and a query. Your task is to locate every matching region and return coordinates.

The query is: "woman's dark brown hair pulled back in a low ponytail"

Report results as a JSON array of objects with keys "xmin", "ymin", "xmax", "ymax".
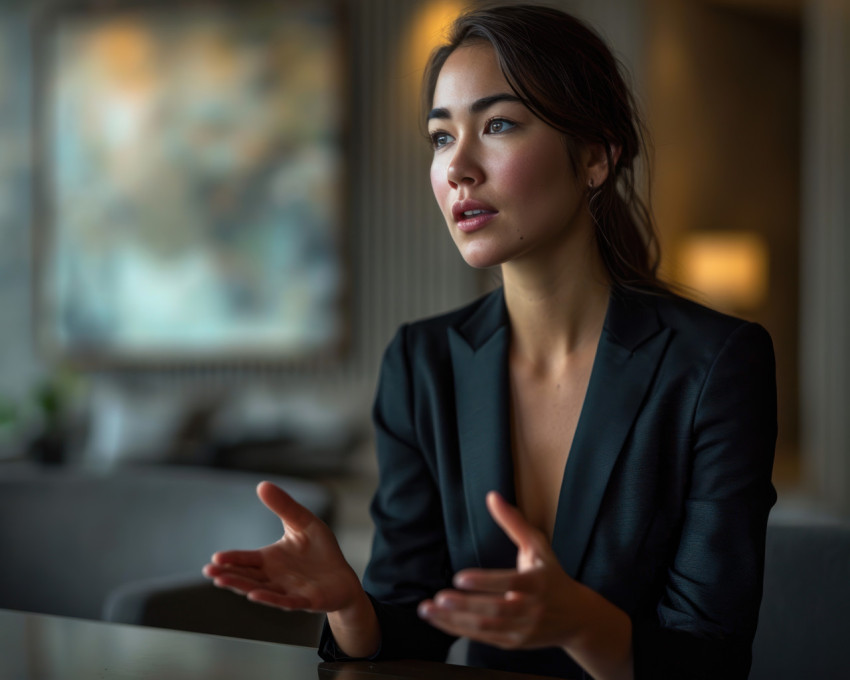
[{"xmin": 423, "ymin": 5, "xmax": 665, "ymax": 291}]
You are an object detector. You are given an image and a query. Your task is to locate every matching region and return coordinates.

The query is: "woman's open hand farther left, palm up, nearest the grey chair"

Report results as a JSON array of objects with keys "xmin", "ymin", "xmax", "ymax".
[{"xmin": 204, "ymin": 482, "xmax": 364, "ymax": 612}]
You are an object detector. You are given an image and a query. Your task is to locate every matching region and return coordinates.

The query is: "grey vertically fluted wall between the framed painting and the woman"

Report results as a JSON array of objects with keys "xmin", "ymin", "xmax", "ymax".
[{"xmin": 334, "ymin": 0, "xmax": 478, "ymax": 404}]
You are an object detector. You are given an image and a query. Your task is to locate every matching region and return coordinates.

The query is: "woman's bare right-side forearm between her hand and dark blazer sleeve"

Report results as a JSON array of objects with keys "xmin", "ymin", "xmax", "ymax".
[{"xmin": 564, "ymin": 583, "xmax": 634, "ymax": 680}]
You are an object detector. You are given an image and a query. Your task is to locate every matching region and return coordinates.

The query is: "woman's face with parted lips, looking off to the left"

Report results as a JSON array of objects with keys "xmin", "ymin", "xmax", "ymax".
[{"xmin": 428, "ymin": 43, "xmax": 592, "ymax": 267}]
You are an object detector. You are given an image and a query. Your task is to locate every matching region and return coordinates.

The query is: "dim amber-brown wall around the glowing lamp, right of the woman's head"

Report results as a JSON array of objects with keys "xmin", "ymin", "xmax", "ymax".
[{"xmin": 648, "ymin": 0, "xmax": 802, "ymax": 484}]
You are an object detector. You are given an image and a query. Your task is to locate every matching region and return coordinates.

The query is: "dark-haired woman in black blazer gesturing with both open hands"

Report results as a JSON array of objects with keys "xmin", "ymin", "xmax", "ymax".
[{"xmin": 206, "ymin": 6, "xmax": 776, "ymax": 679}]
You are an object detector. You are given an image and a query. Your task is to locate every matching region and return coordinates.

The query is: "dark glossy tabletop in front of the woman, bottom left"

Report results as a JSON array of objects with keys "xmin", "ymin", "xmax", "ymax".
[{"xmin": 0, "ymin": 609, "xmax": 551, "ymax": 680}]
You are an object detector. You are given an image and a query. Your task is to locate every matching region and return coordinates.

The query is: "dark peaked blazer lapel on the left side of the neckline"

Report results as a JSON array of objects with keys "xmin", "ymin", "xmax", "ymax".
[{"xmin": 448, "ymin": 289, "xmax": 516, "ymax": 568}]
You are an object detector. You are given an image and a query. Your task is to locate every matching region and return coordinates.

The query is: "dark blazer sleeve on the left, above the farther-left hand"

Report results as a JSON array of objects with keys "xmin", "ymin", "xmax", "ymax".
[{"xmin": 319, "ymin": 325, "xmax": 455, "ymax": 661}]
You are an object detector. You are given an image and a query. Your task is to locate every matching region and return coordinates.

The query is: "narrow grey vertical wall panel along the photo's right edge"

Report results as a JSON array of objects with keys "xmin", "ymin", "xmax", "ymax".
[{"xmin": 800, "ymin": 0, "xmax": 850, "ymax": 516}]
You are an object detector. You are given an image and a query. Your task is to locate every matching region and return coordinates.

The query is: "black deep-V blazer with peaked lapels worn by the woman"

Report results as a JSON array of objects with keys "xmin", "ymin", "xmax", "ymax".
[{"xmin": 320, "ymin": 289, "xmax": 776, "ymax": 680}]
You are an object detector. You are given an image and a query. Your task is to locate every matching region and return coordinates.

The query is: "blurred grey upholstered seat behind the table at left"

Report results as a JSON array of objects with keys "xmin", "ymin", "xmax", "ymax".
[{"xmin": 0, "ymin": 463, "xmax": 333, "ymax": 644}]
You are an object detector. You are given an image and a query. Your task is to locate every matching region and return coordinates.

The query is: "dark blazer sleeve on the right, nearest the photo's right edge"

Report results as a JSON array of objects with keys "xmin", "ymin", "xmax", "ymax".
[{"xmin": 633, "ymin": 323, "xmax": 777, "ymax": 680}]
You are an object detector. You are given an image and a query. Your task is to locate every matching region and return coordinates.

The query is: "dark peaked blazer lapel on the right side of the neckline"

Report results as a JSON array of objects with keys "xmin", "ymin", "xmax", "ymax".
[{"xmin": 553, "ymin": 292, "xmax": 670, "ymax": 577}]
